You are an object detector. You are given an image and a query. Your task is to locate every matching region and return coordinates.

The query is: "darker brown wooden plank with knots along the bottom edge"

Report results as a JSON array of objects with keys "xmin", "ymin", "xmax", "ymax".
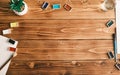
[{"xmin": 7, "ymin": 60, "xmax": 120, "ymax": 75}]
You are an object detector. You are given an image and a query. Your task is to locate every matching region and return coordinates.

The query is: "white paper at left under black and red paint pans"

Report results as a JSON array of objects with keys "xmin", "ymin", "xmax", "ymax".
[{"xmin": 0, "ymin": 35, "xmax": 18, "ymax": 75}]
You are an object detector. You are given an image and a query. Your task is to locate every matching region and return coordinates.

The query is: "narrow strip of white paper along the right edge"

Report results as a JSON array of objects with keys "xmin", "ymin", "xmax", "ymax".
[{"xmin": 116, "ymin": 0, "xmax": 120, "ymax": 54}]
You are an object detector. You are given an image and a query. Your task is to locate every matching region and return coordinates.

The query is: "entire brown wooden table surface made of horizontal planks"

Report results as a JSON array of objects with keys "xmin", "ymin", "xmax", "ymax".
[{"xmin": 0, "ymin": 0, "xmax": 120, "ymax": 75}]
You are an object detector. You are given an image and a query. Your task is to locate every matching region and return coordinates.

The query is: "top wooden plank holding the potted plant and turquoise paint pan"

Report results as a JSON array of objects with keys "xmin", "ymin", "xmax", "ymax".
[{"xmin": 0, "ymin": 0, "xmax": 115, "ymax": 20}]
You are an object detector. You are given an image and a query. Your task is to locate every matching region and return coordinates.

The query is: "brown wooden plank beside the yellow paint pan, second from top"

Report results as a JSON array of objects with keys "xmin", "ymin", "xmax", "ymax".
[{"xmin": 0, "ymin": 19, "xmax": 115, "ymax": 40}]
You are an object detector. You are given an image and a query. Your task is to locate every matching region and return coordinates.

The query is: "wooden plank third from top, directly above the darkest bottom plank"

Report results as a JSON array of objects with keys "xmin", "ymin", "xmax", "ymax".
[{"xmin": 9, "ymin": 40, "xmax": 113, "ymax": 60}]
